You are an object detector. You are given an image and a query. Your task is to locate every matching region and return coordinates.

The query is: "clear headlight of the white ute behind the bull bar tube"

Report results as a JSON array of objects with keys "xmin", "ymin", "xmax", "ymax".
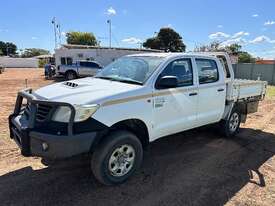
[{"xmin": 52, "ymin": 104, "xmax": 99, "ymax": 122}]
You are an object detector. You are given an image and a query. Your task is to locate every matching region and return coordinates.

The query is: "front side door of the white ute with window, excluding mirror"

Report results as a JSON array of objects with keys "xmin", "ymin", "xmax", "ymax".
[{"xmin": 153, "ymin": 58, "xmax": 198, "ymax": 139}]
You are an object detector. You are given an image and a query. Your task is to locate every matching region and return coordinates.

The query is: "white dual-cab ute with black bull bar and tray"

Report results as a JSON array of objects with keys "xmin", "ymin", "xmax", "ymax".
[{"xmin": 9, "ymin": 53, "xmax": 267, "ymax": 185}]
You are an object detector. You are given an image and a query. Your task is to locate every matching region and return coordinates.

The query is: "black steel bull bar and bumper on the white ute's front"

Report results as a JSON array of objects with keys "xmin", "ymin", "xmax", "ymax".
[{"xmin": 9, "ymin": 90, "xmax": 103, "ymax": 159}]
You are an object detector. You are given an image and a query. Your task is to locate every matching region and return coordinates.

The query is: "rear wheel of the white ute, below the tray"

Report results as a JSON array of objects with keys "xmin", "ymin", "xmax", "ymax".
[{"xmin": 220, "ymin": 108, "xmax": 241, "ymax": 137}]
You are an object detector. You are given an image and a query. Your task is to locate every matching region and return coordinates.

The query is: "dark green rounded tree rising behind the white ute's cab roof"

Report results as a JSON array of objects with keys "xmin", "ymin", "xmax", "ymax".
[{"xmin": 143, "ymin": 28, "xmax": 186, "ymax": 52}]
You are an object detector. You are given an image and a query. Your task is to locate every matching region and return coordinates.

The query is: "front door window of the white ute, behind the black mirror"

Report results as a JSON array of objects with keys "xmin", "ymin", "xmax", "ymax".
[{"xmin": 160, "ymin": 59, "xmax": 193, "ymax": 87}]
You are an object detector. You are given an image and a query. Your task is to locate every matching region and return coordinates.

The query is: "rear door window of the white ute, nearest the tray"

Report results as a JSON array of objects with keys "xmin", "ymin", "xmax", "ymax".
[{"xmin": 196, "ymin": 59, "xmax": 219, "ymax": 84}]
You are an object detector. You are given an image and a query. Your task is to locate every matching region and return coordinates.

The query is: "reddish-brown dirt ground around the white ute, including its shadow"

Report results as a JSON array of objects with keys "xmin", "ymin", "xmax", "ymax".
[{"xmin": 0, "ymin": 69, "xmax": 275, "ymax": 206}]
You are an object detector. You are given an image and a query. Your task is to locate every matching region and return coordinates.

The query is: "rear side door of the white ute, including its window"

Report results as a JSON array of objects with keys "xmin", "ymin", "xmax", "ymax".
[{"xmin": 195, "ymin": 58, "xmax": 226, "ymax": 126}]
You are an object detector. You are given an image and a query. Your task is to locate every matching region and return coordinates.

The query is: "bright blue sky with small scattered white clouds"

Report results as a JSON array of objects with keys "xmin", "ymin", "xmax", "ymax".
[{"xmin": 0, "ymin": 0, "xmax": 275, "ymax": 59}]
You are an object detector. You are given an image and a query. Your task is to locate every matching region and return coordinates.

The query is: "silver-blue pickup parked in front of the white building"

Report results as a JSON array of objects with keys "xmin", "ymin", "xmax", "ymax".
[{"xmin": 57, "ymin": 61, "xmax": 102, "ymax": 80}]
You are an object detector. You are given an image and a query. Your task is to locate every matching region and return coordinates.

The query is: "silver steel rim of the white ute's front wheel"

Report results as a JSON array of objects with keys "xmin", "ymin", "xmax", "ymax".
[{"xmin": 108, "ymin": 144, "xmax": 136, "ymax": 177}]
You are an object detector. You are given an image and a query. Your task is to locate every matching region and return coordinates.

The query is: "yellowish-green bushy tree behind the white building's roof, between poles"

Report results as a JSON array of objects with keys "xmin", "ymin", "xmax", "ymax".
[{"xmin": 66, "ymin": 31, "xmax": 98, "ymax": 46}]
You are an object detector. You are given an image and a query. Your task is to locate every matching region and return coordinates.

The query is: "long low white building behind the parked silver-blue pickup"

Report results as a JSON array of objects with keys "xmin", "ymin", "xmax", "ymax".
[{"xmin": 55, "ymin": 44, "xmax": 162, "ymax": 66}]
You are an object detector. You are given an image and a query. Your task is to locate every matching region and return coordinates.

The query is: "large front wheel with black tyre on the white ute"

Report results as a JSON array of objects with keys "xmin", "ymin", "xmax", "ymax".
[{"xmin": 91, "ymin": 131, "xmax": 143, "ymax": 185}]
